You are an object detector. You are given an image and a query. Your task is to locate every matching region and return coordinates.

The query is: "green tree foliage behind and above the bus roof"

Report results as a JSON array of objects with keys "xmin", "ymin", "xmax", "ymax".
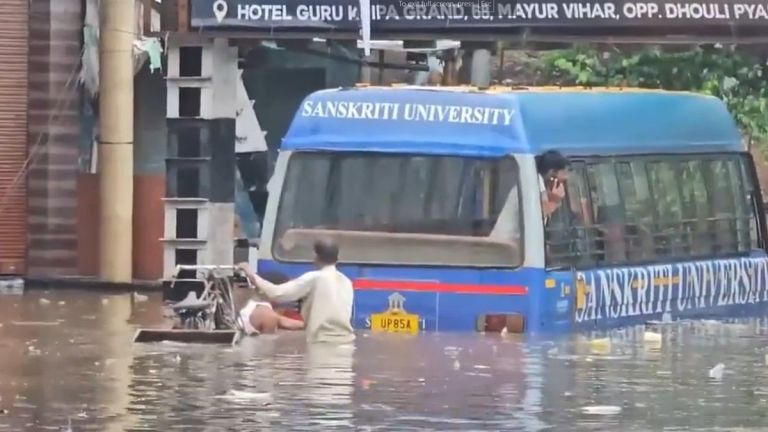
[{"xmin": 523, "ymin": 46, "xmax": 768, "ymax": 142}]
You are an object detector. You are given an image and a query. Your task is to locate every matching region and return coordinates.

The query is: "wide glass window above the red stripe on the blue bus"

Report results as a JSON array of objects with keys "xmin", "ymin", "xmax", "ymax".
[{"xmin": 273, "ymin": 153, "xmax": 522, "ymax": 267}]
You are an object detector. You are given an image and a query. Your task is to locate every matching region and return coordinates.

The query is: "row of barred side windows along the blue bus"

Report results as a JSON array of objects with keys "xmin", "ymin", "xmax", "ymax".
[{"xmin": 547, "ymin": 155, "xmax": 759, "ymax": 265}]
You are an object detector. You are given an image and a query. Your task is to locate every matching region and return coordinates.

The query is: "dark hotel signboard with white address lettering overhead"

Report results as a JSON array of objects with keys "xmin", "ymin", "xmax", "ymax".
[{"xmin": 189, "ymin": 0, "xmax": 768, "ymax": 31}]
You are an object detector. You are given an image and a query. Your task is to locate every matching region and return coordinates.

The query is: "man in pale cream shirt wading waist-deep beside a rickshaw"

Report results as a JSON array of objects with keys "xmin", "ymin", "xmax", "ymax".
[{"xmin": 238, "ymin": 240, "xmax": 355, "ymax": 343}]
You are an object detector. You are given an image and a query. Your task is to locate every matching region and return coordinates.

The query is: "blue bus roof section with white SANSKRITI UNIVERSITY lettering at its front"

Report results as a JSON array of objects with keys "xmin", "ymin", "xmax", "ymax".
[{"xmin": 282, "ymin": 86, "xmax": 743, "ymax": 157}]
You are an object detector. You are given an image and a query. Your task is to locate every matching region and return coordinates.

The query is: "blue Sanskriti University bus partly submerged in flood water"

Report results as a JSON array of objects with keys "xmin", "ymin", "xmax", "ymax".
[{"xmin": 259, "ymin": 87, "xmax": 768, "ymax": 333}]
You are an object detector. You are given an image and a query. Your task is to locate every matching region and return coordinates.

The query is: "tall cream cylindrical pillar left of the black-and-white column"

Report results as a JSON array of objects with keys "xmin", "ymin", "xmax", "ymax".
[{"xmin": 98, "ymin": 0, "xmax": 136, "ymax": 282}]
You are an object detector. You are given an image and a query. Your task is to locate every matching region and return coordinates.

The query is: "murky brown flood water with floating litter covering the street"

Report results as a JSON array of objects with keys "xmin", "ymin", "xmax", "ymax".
[{"xmin": 0, "ymin": 291, "xmax": 768, "ymax": 431}]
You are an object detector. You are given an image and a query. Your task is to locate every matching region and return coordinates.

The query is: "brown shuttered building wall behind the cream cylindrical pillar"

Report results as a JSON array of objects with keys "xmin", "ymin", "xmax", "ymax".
[{"xmin": 0, "ymin": 0, "xmax": 165, "ymax": 279}]
